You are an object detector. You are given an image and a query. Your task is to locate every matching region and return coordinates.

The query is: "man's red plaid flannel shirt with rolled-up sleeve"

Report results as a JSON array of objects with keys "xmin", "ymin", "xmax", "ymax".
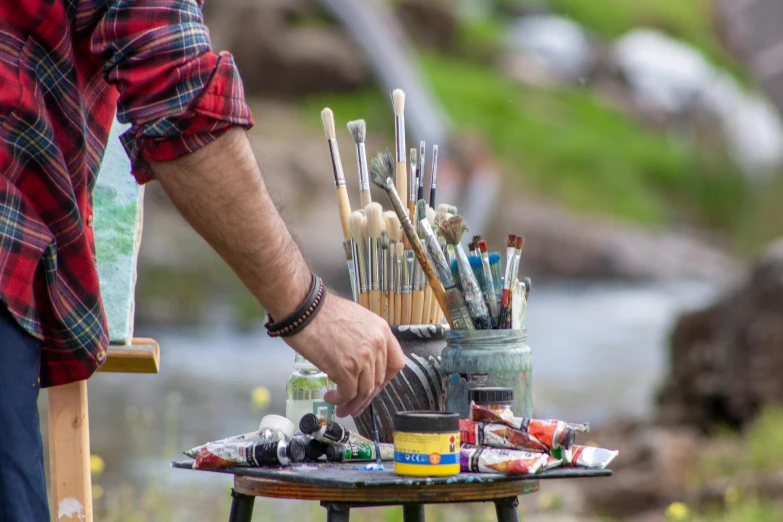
[{"xmin": 0, "ymin": 0, "xmax": 252, "ymax": 386}]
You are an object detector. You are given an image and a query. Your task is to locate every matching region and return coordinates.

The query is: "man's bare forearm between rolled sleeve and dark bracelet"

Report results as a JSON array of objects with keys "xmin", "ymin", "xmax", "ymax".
[{"xmin": 152, "ymin": 128, "xmax": 310, "ymax": 319}]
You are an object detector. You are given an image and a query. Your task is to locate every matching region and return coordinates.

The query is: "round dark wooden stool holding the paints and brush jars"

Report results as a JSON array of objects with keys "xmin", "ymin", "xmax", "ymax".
[{"xmin": 172, "ymin": 461, "xmax": 612, "ymax": 522}]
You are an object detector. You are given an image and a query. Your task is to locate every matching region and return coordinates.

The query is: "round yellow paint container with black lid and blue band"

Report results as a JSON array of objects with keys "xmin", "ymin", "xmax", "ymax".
[{"xmin": 394, "ymin": 411, "xmax": 459, "ymax": 477}]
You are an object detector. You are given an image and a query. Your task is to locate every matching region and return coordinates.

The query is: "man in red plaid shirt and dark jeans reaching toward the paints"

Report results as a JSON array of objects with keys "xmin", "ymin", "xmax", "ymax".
[{"xmin": 0, "ymin": 0, "xmax": 404, "ymax": 522}]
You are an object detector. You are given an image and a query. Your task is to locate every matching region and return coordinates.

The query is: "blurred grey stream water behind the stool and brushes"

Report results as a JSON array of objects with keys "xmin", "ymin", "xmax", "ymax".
[{"xmin": 41, "ymin": 282, "xmax": 717, "ymax": 510}]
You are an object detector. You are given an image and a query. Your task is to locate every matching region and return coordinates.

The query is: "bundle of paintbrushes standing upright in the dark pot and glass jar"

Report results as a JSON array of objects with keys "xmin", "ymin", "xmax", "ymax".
[{"xmin": 321, "ymin": 89, "xmax": 530, "ymax": 330}]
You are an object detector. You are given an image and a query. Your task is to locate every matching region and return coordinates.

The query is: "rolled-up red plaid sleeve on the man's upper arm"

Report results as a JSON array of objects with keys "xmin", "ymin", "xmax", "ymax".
[{"xmin": 90, "ymin": 0, "xmax": 253, "ymax": 183}]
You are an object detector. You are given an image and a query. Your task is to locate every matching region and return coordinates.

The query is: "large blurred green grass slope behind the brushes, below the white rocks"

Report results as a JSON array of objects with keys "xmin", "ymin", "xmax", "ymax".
[{"xmin": 304, "ymin": 55, "xmax": 746, "ymax": 229}]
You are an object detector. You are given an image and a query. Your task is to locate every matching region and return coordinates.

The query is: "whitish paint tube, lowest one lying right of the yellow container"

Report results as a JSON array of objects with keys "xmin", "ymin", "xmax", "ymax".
[{"xmin": 459, "ymin": 444, "xmax": 561, "ymax": 475}]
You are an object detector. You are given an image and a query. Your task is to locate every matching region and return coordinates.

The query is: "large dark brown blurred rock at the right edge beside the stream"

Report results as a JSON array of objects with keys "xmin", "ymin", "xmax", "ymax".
[{"xmin": 659, "ymin": 239, "xmax": 783, "ymax": 431}]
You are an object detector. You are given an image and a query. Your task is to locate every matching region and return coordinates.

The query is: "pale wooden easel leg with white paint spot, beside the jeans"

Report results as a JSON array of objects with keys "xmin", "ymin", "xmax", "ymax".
[{"xmin": 47, "ymin": 381, "xmax": 92, "ymax": 522}]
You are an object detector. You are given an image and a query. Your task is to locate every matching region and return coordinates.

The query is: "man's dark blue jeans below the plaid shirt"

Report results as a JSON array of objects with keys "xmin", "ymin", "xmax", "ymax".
[{"xmin": 0, "ymin": 303, "xmax": 49, "ymax": 522}]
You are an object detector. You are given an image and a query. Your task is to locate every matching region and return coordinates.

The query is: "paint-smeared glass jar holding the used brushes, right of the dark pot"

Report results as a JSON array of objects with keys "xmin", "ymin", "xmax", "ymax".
[{"xmin": 440, "ymin": 329, "xmax": 533, "ymax": 419}]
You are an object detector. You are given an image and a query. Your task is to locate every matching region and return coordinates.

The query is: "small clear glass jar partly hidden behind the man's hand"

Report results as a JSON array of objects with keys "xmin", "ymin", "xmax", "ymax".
[{"xmin": 285, "ymin": 353, "xmax": 334, "ymax": 424}]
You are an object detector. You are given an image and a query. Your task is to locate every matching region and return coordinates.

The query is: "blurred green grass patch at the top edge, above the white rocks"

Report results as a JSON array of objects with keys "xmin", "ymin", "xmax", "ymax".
[{"xmin": 498, "ymin": 0, "xmax": 748, "ymax": 81}]
